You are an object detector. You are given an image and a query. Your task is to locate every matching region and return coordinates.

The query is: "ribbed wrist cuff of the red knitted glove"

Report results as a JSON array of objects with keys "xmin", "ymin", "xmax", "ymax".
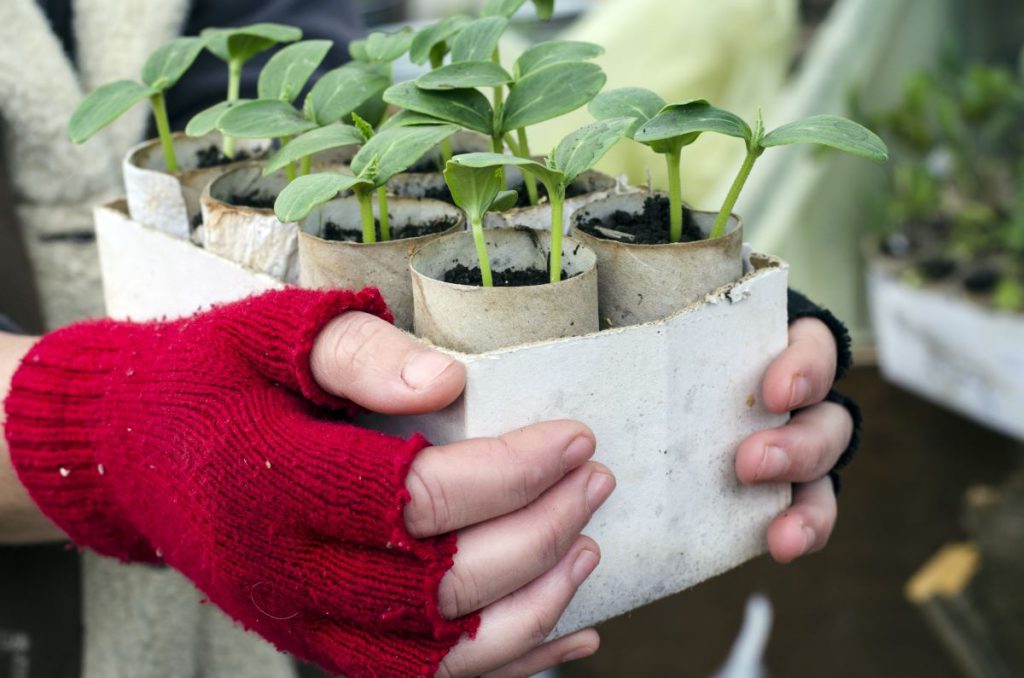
[{"xmin": 5, "ymin": 321, "xmax": 155, "ymax": 561}]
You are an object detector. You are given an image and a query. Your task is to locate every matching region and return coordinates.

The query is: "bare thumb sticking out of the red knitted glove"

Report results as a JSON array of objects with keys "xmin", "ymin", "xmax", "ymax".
[{"xmin": 309, "ymin": 311, "xmax": 466, "ymax": 415}]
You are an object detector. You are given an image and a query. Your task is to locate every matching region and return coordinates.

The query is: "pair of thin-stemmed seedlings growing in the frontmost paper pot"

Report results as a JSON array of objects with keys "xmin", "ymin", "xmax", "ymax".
[{"xmin": 444, "ymin": 118, "xmax": 633, "ymax": 286}]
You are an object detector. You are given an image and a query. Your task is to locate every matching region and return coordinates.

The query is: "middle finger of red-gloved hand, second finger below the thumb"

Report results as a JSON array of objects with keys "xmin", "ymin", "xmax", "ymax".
[{"xmin": 438, "ymin": 462, "xmax": 615, "ymax": 619}]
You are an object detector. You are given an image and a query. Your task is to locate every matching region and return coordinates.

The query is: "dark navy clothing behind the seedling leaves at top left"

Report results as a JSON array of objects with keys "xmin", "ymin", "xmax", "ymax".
[{"xmin": 161, "ymin": 0, "xmax": 364, "ymax": 129}]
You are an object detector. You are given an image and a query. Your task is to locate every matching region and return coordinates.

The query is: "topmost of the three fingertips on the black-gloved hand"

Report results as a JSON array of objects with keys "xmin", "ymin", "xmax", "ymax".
[{"xmin": 761, "ymin": 317, "xmax": 837, "ymax": 413}]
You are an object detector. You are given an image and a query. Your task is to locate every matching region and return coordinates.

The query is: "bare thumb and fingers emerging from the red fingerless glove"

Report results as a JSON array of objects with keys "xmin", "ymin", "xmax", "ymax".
[{"xmin": 311, "ymin": 312, "xmax": 614, "ymax": 676}]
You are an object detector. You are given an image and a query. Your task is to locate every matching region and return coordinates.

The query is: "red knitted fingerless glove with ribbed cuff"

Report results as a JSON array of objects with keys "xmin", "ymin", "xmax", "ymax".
[{"xmin": 6, "ymin": 289, "xmax": 478, "ymax": 677}]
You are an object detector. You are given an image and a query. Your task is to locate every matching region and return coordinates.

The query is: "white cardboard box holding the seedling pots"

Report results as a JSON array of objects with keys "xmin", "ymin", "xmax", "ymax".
[{"xmin": 96, "ymin": 204, "xmax": 791, "ymax": 635}]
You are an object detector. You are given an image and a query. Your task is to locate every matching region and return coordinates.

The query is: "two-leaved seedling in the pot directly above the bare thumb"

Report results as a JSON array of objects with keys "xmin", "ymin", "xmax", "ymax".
[{"xmin": 273, "ymin": 125, "xmax": 459, "ymax": 243}]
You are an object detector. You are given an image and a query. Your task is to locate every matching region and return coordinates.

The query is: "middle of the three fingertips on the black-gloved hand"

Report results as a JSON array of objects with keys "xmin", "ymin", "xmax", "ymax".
[{"xmin": 736, "ymin": 402, "xmax": 853, "ymax": 484}]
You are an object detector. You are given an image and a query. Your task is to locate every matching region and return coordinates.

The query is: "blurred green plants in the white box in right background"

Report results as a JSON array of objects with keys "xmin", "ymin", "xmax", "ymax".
[{"xmin": 871, "ymin": 53, "xmax": 1024, "ymax": 310}]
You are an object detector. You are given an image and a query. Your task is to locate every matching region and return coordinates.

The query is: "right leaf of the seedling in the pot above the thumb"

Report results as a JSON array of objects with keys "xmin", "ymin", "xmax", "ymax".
[{"xmin": 352, "ymin": 125, "xmax": 459, "ymax": 187}]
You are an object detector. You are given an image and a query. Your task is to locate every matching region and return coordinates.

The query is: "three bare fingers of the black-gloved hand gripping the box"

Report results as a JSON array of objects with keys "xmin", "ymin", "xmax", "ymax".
[{"xmin": 736, "ymin": 317, "xmax": 853, "ymax": 562}]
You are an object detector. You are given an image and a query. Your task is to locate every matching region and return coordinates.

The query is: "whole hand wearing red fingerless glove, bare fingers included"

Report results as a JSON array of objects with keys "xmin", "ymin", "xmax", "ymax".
[{"xmin": 8, "ymin": 289, "xmax": 613, "ymax": 676}]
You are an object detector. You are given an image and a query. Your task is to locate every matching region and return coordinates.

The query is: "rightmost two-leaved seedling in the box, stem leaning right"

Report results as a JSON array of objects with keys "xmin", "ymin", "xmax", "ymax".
[{"xmin": 634, "ymin": 99, "xmax": 889, "ymax": 239}]
